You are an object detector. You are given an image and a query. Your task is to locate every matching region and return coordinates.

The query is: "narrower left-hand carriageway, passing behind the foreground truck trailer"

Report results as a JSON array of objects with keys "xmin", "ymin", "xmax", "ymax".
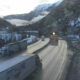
[{"xmin": 0, "ymin": 38, "xmax": 49, "ymax": 65}]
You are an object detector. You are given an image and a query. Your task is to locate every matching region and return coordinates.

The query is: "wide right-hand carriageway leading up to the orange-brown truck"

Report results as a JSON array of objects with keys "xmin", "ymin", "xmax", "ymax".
[{"xmin": 26, "ymin": 40, "xmax": 67, "ymax": 80}]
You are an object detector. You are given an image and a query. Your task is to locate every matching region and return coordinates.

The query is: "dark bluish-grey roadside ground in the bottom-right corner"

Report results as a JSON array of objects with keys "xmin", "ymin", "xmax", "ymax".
[{"xmin": 65, "ymin": 41, "xmax": 80, "ymax": 80}]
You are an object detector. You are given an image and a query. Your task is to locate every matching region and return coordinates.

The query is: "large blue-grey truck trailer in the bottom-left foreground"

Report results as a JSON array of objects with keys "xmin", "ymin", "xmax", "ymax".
[{"xmin": 0, "ymin": 54, "xmax": 42, "ymax": 80}]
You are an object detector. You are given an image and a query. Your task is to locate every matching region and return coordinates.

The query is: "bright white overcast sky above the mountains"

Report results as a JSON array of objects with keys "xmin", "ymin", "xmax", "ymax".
[{"xmin": 0, "ymin": 0, "xmax": 59, "ymax": 16}]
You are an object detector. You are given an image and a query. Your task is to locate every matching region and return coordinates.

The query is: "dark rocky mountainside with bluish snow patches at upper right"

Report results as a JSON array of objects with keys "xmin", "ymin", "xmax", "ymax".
[{"xmin": 26, "ymin": 0, "xmax": 80, "ymax": 35}]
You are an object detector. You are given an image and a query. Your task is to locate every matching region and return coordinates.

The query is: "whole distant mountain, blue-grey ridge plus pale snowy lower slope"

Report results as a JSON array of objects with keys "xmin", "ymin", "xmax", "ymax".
[{"xmin": 4, "ymin": 3, "xmax": 59, "ymax": 26}]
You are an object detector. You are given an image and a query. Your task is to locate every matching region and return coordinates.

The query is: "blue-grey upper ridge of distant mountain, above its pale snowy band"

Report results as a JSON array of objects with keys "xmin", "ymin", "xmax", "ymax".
[{"xmin": 4, "ymin": 4, "xmax": 52, "ymax": 21}]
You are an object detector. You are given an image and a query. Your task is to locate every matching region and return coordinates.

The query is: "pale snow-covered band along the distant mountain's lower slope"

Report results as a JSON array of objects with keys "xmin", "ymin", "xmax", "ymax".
[{"xmin": 6, "ymin": 11, "xmax": 49, "ymax": 27}]
